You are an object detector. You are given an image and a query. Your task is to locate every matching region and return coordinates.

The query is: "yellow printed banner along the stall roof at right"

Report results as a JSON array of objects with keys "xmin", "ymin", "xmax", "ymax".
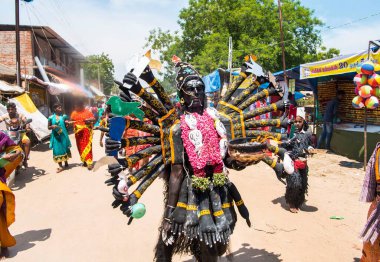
[{"xmin": 300, "ymin": 50, "xmax": 380, "ymax": 79}]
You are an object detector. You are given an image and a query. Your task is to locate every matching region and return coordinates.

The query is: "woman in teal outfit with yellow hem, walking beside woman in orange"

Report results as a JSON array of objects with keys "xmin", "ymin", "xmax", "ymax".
[{"xmin": 48, "ymin": 103, "xmax": 71, "ymax": 173}]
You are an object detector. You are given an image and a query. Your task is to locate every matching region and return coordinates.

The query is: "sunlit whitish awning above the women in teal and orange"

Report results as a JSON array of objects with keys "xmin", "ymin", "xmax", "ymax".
[{"xmin": 48, "ymin": 73, "xmax": 94, "ymax": 98}]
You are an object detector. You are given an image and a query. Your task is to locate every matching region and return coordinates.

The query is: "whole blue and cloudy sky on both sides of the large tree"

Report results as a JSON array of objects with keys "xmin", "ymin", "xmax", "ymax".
[{"xmin": 0, "ymin": 0, "xmax": 380, "ymax": 79}]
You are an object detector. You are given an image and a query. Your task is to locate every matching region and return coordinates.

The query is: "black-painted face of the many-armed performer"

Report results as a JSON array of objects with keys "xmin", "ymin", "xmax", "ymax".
[{"xmin": 181, "ymin": 79, "xmax": 205, "ymax": 111}]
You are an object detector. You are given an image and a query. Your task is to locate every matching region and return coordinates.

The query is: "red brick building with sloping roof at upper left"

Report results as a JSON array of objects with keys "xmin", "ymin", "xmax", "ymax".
[{"xmin": 0, "ymin": 25, "xmax": 85, "ymax": 114}]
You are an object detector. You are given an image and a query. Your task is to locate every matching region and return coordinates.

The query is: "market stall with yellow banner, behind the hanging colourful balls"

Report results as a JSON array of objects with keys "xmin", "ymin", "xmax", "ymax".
[{"xmin": 300, "ymin": 47, "xmax": 380, "ymax": 161}]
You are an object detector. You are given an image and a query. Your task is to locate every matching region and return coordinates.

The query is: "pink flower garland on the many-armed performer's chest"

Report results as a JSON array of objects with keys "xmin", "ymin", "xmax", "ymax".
[{"xmin": 181, "ymin": 111, "xmax": 223, "ymax": 177}]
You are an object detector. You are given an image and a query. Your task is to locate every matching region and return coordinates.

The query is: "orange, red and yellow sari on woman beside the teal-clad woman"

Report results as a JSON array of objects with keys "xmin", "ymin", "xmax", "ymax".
[{"xmin": 71, "ymin": 109, "xmax": 94, "ymax": 165}]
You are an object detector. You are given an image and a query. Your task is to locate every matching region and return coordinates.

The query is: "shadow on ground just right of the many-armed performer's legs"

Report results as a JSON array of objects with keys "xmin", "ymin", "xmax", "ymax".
[{"xmin": 185, "ymin": 243, "xmax": 282, "ymax": 262}]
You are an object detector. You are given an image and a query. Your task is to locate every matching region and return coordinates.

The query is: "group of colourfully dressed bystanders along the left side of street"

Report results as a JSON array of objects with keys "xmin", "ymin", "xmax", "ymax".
[{"xmin": 0, "ymin": 100, "xmax": 107, "ymax": 259}]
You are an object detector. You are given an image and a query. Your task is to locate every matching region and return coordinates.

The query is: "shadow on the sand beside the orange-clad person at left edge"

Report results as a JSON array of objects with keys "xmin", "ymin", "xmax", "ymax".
[{"xmin": 9, "ymin": 228, "xmax": 51, "ymax": 257}]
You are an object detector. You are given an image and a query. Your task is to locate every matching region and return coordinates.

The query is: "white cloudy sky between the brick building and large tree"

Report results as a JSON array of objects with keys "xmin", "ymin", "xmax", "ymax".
[{"xmin": 0, "ymin": 0, "xmax": 186, "ymax": 79}]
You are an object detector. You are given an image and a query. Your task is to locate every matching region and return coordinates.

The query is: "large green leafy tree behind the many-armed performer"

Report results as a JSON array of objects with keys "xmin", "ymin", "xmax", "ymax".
[{"xmin": 147, "ymin": 0, "xmax": 339, "ymax": 82}]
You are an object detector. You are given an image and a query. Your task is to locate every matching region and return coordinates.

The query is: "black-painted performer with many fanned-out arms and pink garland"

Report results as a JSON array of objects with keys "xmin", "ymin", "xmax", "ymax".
[{"xmin": 106, "ymin": 57, "xmax": 289, "ymax": 261}]
